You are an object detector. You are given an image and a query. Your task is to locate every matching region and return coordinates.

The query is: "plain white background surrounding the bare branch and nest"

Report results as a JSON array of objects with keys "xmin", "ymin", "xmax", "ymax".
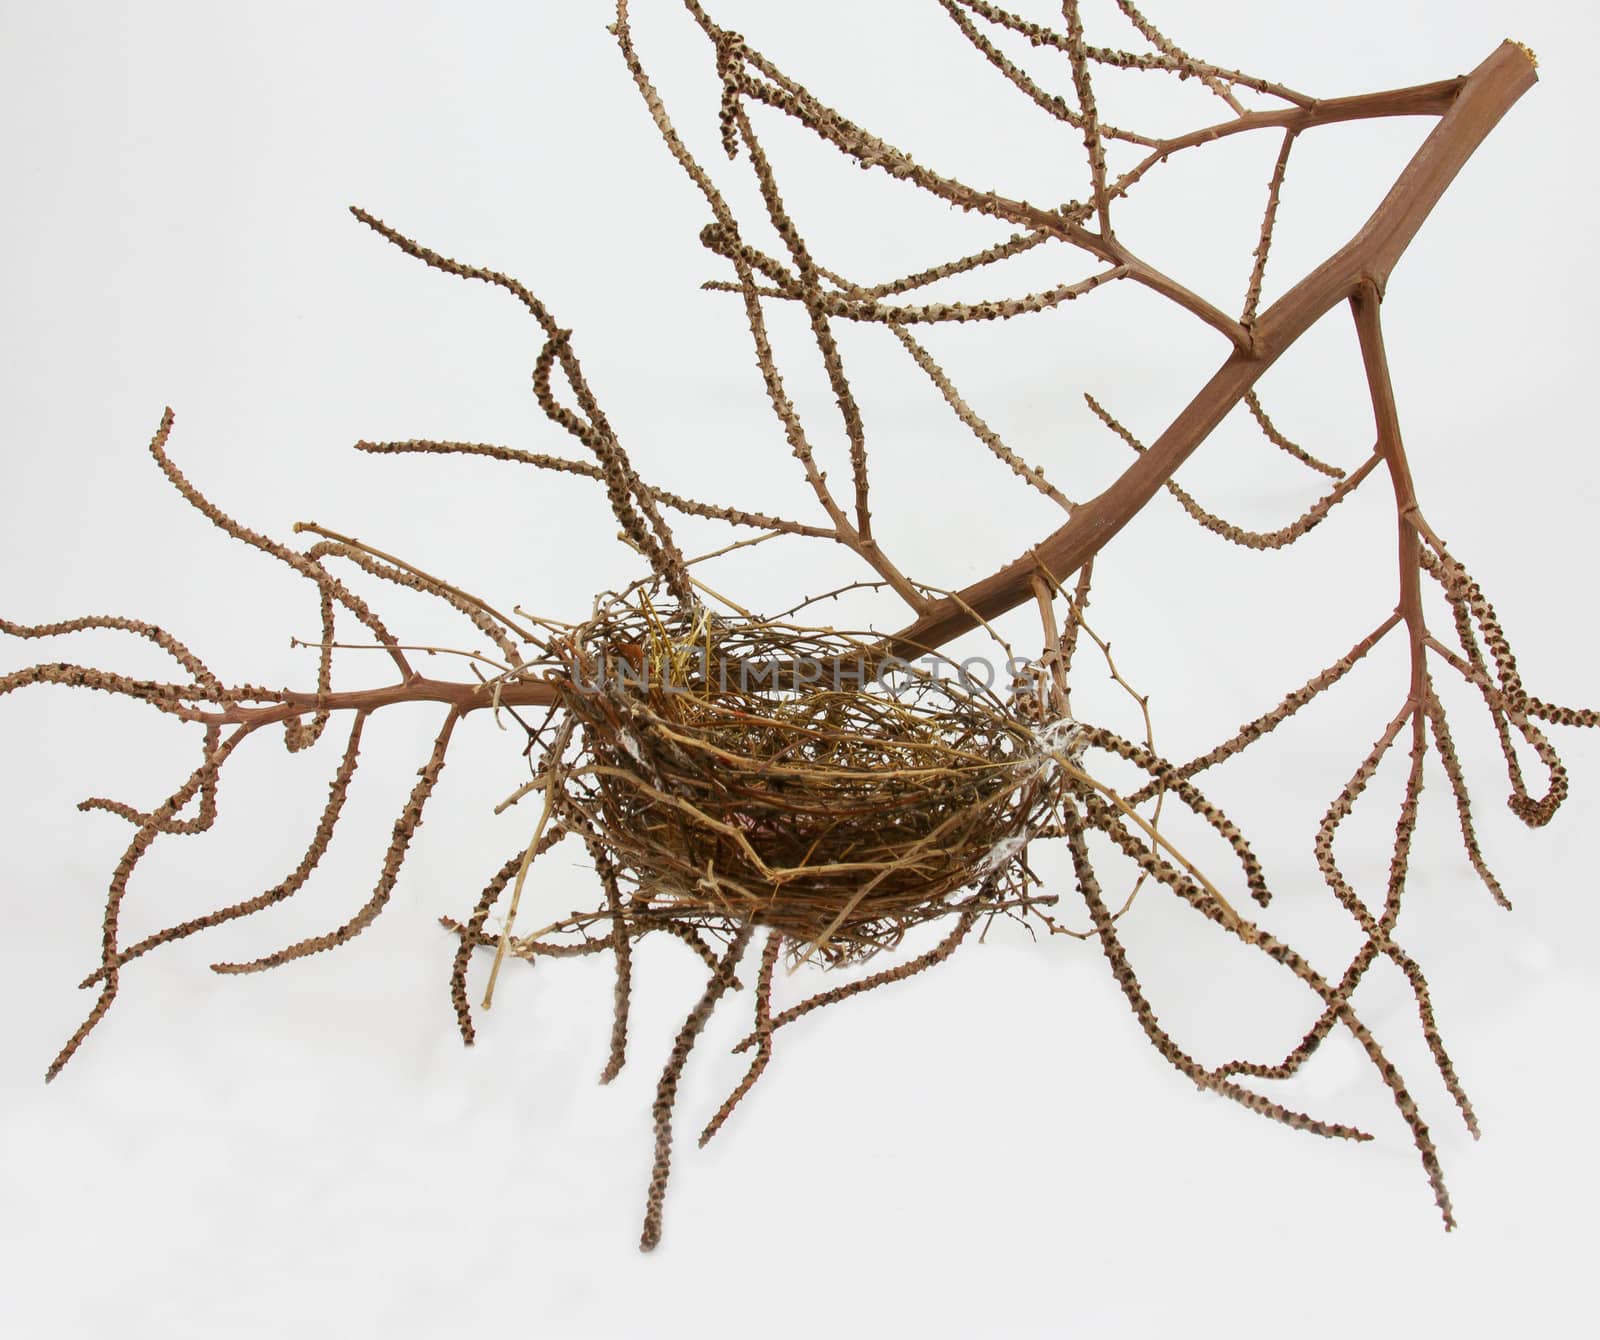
[{"xmin": 0, "ymin": 0, "xmax": 1600, "ymax": 1337}]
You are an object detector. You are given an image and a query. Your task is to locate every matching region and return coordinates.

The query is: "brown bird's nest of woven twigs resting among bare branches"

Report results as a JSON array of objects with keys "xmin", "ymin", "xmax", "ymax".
[{"xmin": 558, "ymin": 598, "xmax": 1053, "ymax": 964}]
